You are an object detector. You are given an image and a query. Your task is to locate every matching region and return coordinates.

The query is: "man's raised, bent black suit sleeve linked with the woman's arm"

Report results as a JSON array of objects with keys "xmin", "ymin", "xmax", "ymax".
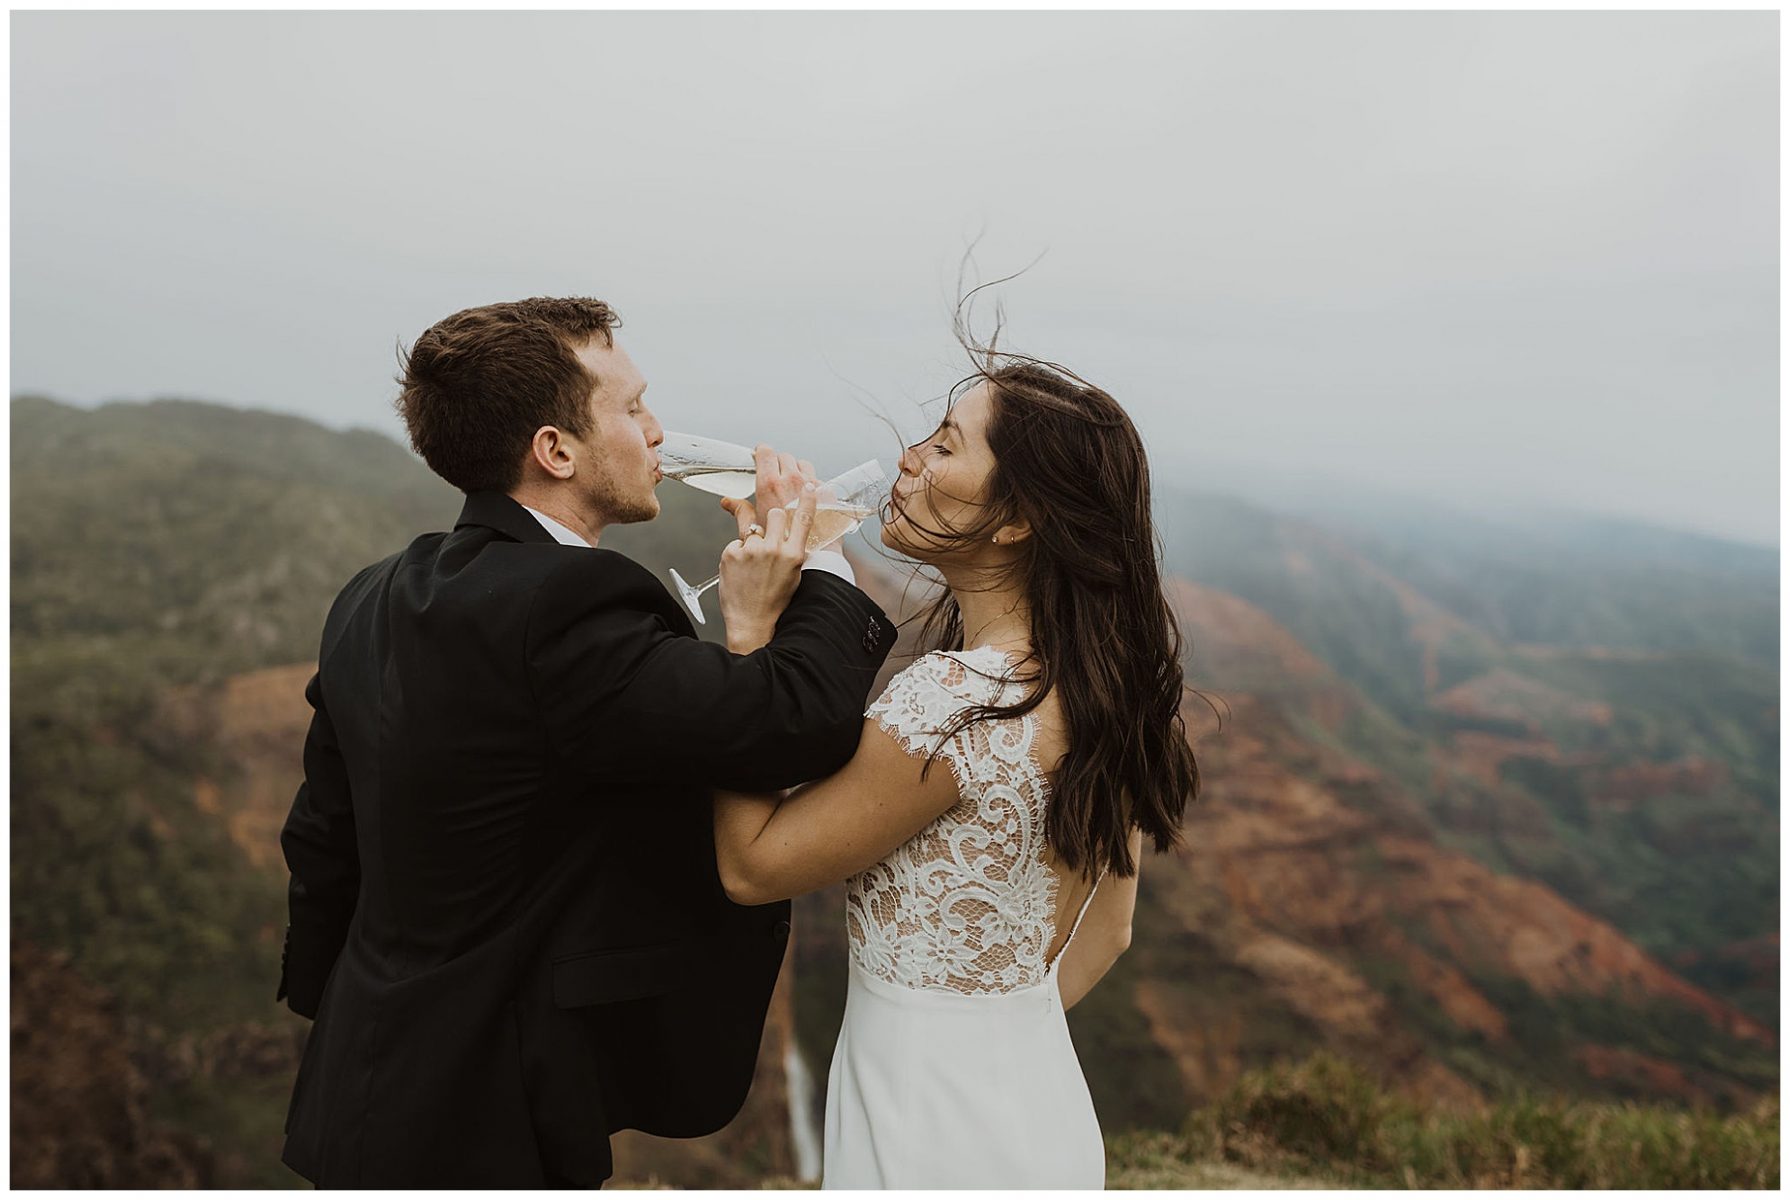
[{"xmin": 528, "ymin": 555, "xmax": 895, "ymax": 792}]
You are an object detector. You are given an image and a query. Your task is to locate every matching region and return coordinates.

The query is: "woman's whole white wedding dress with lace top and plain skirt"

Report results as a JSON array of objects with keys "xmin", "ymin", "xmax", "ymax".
[{"xmin": 822, "ymin": 647, "xmax": 1106, "ymax": 1189}]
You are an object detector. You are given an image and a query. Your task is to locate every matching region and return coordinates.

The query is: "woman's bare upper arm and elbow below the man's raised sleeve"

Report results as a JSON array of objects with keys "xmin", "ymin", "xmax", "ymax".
[{"xmin": 714, "ymin": 718, "xmax": 966, "ymax": 906}]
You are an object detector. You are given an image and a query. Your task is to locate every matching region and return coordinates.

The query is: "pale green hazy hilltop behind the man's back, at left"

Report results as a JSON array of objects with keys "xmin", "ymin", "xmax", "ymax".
[{"xmin": 11, "ymin": 398, "xmax": 460, "ymax": 670}]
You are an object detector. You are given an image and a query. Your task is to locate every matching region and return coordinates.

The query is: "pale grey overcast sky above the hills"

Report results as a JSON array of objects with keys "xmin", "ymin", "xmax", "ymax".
[{"xmin": 11, "ymin": 13, "xmax": 1779, "ymax": 544}]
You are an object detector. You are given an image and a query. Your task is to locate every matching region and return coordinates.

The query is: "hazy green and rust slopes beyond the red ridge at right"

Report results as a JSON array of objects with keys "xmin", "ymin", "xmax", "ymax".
[{"xmin": 1158, "ymin": 493, "xmax": 1779, "ymax": 1021}]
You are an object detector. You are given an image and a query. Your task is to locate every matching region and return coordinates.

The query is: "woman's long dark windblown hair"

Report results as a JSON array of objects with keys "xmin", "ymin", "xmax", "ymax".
[{"xmin": 884, "ymin": 295, "xmax": 1199, "ymax": 878}]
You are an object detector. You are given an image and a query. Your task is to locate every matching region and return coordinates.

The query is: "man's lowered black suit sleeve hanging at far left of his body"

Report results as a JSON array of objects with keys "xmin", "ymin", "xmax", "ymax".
[{"xmin": 276, "ymin": 673, "xmax": 360, "ymax": 1017}]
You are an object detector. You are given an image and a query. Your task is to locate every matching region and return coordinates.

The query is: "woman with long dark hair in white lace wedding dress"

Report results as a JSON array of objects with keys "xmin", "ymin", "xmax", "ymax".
[{"xmin": 714, "ymin": 343, "xmax": 1199, "ymax": 1189}]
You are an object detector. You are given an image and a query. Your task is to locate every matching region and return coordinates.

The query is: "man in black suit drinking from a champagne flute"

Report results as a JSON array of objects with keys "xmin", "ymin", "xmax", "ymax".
[{"xmin": 279, "ymin": 299, "xmax": 895, "ymax": 1187}]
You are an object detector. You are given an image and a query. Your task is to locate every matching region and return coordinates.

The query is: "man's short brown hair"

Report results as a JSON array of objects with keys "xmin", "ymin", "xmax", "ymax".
[{"xmin": 396, "ymin": 296, "xmax": 621, "ymax": 493}]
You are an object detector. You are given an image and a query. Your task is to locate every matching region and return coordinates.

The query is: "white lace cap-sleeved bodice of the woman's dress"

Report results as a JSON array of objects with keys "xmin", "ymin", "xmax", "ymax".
[{"xmin": 845, "ymin": 647, "xmax": 1099, "ymax": 992}]
